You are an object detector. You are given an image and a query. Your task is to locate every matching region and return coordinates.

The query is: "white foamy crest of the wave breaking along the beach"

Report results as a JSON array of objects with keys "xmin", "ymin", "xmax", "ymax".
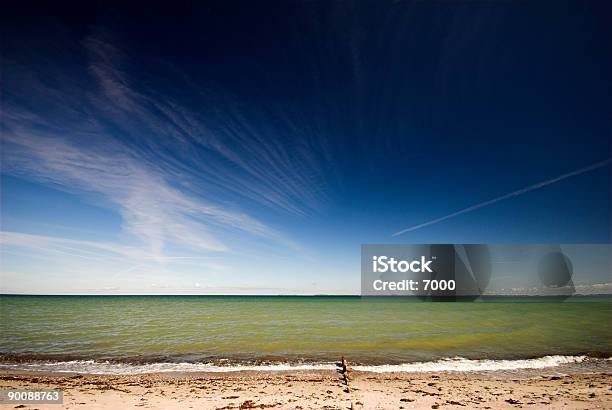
[{"xmin": 0, "ymin": 356, "xmax": 586, "ymax": 375}]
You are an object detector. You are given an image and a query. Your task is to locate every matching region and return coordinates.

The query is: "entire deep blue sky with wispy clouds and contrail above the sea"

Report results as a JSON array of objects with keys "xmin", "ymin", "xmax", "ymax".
[{"xmin": 0, "ymin": 1, "xmax": 612, "ymax": 294}]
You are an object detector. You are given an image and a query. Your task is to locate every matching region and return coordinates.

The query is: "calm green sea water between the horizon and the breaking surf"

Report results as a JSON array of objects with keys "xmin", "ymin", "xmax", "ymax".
[{"xmin": 0, "ymin": 296, "xmax": 612, "ymax": 364}]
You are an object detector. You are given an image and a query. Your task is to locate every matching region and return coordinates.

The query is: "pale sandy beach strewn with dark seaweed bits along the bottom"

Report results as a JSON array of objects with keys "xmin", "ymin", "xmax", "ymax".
[{"xmin": 0, "ymin": 371, "xmax": 612, "ymax": 410}]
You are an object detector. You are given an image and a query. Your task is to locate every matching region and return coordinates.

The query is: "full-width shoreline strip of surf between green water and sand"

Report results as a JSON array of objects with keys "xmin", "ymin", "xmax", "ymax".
[{"xmin": 0, "ymin": 355, "xmax": 612, "ymax": 375}]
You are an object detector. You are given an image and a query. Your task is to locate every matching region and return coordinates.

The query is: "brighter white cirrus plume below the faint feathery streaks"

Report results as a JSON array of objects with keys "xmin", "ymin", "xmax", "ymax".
[{"xmin": 3, "ymin": 129, "xmax": 292, "ymax": 258}]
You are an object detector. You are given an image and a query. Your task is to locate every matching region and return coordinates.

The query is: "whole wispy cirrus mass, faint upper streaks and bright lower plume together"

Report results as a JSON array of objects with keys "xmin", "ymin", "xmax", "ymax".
[{"xmin": 2, "ymin": 29, "xmax": 332, "ymax": 260}]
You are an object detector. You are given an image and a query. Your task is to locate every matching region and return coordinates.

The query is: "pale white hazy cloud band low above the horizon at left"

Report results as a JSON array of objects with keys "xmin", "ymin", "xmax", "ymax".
[{"xmin": 0, "ymin": 231, "xmax": 226, "ymax": 294}]
